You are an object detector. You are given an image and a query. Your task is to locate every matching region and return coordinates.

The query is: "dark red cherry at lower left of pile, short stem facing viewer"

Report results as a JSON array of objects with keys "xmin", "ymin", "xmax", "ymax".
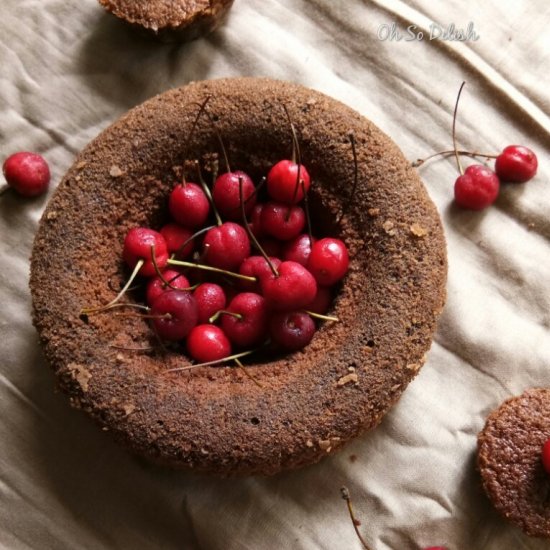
[{"xmin": 151, "ymin": 290, "xmax": 197, "ymax": 340}]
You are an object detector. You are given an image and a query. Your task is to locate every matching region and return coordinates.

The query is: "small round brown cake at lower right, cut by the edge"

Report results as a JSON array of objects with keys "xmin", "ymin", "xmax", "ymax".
[{"xmin": 477, "ymin": 388, "xmax": 550, "ymax": 538}]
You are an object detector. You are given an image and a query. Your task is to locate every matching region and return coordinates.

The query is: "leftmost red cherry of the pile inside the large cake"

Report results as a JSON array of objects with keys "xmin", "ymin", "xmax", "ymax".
[{"xmin": 122, "ymin": 227, "xmax": 168, "ymax": 277}]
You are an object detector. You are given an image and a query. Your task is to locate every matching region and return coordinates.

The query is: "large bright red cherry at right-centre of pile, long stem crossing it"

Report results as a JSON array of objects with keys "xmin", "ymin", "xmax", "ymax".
[{"xmin": 260, "ymin": 261, "xmax": 317, "ymax": 311}]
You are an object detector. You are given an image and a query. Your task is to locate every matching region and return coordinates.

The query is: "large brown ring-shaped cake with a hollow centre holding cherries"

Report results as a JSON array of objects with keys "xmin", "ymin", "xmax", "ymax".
[{"xmin": 30, "ymin": 78, "xmax": 447, "ymax": 475}]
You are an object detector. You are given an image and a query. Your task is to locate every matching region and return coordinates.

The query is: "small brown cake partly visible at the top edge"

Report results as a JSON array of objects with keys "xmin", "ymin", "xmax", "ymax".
[{"xmin": 99, "ymin": 0, "xmax": 233, "ymax": 42}]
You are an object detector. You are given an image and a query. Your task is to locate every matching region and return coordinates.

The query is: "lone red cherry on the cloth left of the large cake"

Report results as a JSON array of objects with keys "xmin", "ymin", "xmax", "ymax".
[{"xmin": 2, "ymin": 151, "xmax": 50, "ymax": 197}]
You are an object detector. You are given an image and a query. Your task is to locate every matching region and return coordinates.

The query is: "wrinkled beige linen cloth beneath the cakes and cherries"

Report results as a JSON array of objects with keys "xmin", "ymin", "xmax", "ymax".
[{"xmin": 0, "ymin": 0, "xmax": 550, "ymax": 550}]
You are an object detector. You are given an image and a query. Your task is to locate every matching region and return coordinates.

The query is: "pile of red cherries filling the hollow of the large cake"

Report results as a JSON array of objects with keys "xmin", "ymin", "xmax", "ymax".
[{"xmin": 123, "ymin": 160, "xmax": 349, "ymax": 363}]
